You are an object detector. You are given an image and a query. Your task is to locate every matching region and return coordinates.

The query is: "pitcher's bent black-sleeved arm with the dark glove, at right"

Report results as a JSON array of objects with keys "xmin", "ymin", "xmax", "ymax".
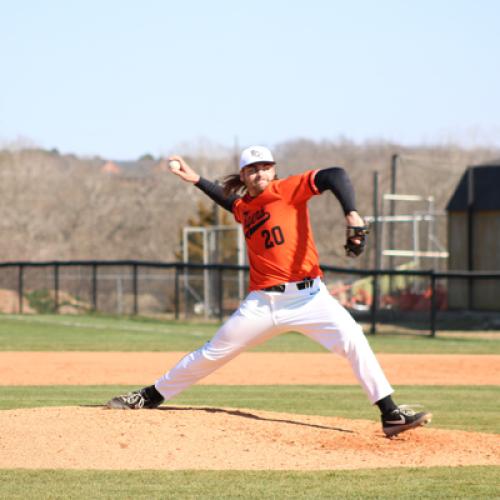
[{"xmin": 314, "ymin": 167, "xmax": 368, "ymax": 257}]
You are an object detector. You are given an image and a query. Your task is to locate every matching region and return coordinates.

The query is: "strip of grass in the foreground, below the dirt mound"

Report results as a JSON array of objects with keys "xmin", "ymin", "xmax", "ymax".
[{"xmin": 0, "ymin": 466, "xmax": 498, "ymax": 499}]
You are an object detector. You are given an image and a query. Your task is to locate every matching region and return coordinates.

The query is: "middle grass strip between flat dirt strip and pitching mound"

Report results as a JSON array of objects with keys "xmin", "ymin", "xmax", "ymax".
[{"xmin": 0, "ymin": 385, "xmax": 500, "ymax": 434}]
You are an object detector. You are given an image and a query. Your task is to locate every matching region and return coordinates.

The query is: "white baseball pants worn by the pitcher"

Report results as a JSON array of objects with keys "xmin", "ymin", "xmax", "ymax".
[{"xmin": 155, "ymin": 278, "xmax": 393, "ymax": 404}]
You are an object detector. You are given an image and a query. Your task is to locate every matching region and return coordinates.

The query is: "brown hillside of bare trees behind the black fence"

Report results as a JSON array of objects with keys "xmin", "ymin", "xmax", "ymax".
[{"xmin": 0, "ymin": 140, "xmax": 500, "ymax": 265}]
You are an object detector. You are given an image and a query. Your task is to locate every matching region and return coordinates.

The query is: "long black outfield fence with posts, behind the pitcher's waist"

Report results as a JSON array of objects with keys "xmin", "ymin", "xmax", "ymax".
[{"xmin": 0, "ymin": 260, "xmax": 500, "ymax": 336}]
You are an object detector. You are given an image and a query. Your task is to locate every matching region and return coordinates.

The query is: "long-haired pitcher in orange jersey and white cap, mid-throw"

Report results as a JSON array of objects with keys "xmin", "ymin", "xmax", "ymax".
[{"xmin": 107, "ymin": 146, "xmax": 431, "ymax": 437}]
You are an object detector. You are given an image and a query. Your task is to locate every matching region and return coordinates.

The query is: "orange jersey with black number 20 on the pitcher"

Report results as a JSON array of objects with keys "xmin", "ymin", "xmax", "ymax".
[{"xmin": 233, "ymin": 170, "xmax": 322, "ymax": 290}]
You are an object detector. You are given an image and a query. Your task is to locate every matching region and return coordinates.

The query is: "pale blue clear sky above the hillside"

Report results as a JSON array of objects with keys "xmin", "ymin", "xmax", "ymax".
[{"xmin": 0, "ymin": 0, "xmax": 500, "ymax": 159}]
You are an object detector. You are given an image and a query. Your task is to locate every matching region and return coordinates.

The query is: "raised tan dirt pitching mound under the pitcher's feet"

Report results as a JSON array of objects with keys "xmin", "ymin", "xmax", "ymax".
[{"xmin": 0, "ymin": 406, "xmax": 500, "ymax": 470}]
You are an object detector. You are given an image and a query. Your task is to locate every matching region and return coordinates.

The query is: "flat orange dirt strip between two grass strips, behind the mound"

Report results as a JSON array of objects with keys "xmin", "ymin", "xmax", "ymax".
[{"xmin": 0, "ymin": 352, "xmax": 500, "ymax": 385}]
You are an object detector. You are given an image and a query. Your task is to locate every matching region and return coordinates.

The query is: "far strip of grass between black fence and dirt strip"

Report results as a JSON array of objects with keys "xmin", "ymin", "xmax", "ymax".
[{"xmin": 0, "ymin": 315, "xmax": 500, "ymax": 354}]
